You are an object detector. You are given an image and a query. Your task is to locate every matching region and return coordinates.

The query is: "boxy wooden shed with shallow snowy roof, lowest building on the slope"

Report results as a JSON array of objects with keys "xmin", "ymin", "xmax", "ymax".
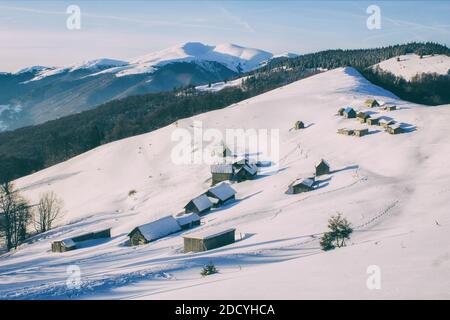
[{"xmin": 183, "ymin": 228, "xmax": 236, "ymax": 252}]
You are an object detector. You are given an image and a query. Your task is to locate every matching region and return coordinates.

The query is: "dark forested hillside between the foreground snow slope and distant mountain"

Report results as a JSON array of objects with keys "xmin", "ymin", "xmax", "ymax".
[{"xmin": 0, "ymin": 43, "xmax": 450, "ymax": 180}]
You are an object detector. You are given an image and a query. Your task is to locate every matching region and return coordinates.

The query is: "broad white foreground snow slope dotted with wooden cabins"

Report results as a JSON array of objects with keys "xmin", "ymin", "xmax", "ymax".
[{"xmin": 0, "ymin": 68, "xmax": 450, "ymax": 299}]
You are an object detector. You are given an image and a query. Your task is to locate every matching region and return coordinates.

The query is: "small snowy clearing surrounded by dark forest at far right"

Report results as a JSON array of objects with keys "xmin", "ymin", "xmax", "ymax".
[{"xmin": 377, "ymin": 54, "xmax": 450, "ymax": 80}]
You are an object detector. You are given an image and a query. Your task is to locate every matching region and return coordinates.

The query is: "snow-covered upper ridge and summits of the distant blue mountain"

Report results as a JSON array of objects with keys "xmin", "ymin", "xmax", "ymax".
[{"xmin": 26, "ymin": 42, "xmax": 273, "ymax": 81}]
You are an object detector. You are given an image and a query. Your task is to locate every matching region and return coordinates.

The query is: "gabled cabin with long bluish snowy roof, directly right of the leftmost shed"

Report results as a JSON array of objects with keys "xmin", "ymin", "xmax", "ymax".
[{"xmin": 128, "ymin": 216, "xmax": 181, "ymax": 246}]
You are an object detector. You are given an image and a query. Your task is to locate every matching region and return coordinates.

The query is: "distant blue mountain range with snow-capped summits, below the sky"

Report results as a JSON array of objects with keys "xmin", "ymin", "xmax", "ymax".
[{"xmin": 0, "ymin": 42, "xmax": 286, "ymax": 131}]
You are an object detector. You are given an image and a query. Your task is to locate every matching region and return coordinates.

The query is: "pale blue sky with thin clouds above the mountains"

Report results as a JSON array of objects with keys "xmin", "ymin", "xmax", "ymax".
[{"xmin": 0, "ymin": 0, "xmax": 450, "ymax": 71}]
